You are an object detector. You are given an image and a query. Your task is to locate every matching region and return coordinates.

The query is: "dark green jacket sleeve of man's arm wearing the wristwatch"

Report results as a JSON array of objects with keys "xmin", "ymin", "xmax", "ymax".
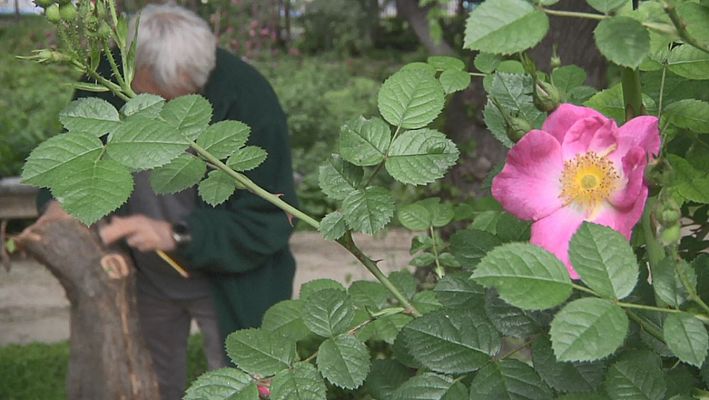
[{"xmin": 182, "ymin": 106, "xmax": 297, "ymax": 273}]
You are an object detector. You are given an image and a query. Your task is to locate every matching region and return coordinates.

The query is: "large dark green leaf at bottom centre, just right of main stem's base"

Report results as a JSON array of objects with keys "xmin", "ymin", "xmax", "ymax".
[{"xmin": 401, "ymin": 308, "xmax": 500, "ymax": 374}]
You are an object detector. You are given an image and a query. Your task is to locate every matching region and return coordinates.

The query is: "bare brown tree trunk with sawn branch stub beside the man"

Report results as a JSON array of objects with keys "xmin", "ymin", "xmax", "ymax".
[{"xmin": 16, "ymin": 219, "xmax": 159, "ymax": 400}]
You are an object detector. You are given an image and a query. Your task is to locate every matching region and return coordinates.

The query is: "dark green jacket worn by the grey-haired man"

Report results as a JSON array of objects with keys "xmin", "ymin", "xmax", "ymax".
[{"xmin": 42, "ymin": 49, "xmax": 297, "ymax": 337}]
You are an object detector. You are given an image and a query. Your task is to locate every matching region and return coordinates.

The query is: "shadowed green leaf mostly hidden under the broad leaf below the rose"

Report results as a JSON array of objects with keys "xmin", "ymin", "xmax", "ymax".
[{"xmin": 485, "ymin": 290, "xmax": 542, "ymax": 338}]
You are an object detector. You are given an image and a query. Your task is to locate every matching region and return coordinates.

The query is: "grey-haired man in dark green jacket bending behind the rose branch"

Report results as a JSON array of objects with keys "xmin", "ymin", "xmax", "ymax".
[{"xmin": 41, "ymin": 5, "xmax": 296, "ymax": 400}]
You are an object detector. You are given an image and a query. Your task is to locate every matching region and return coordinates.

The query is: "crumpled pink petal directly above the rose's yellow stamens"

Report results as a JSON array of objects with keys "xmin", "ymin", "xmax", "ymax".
[{"xmin": 561, "ymin": 117, "xmax": 617, "ymax": 161}]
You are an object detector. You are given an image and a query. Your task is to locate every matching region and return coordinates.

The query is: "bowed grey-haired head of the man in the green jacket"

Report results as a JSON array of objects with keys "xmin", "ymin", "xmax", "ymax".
[{"xmin": 129, "ymin": 4, "xmax": 217, "ymax": 99}]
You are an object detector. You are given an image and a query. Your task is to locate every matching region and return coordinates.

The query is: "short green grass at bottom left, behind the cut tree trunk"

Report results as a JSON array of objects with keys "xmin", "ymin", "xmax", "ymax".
[{"xmin": 0, "ymin": 335, "xmax": 207, "ymax": 400}]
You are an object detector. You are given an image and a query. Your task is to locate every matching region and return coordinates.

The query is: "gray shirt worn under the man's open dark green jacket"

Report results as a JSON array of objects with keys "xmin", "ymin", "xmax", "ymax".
[{"xmin": 125, "ymin": 171, "xmax": 210, "ymax": 299}]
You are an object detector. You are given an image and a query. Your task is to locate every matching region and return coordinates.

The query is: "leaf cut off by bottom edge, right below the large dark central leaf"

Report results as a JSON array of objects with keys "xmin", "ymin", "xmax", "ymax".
[{"xmin": 470, "ymin": 359, "xmax": 552, "ymax": 400}]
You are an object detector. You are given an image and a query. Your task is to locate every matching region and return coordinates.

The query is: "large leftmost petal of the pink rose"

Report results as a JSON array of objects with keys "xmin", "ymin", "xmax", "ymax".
[{"xmin": 492, "ymin": 130, "xmax": 564, "ymax": 220}]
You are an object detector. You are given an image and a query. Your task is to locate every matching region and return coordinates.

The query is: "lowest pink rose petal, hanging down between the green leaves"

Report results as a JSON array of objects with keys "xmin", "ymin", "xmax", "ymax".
[{"xmin": 530, "ymin": 207, "xmax": 584, "ymax": 279}]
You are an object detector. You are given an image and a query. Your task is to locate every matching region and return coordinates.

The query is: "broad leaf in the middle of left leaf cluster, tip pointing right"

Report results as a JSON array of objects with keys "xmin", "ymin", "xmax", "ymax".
[{"xmin": 106, "ymin": 116, "xmax": 189, "ymax": 170}]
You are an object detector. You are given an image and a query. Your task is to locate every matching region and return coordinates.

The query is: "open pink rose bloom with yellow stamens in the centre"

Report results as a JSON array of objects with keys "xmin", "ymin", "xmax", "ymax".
[{"xmin": 492, "ymin": 104, "xmax": 660, "ymax": 279}]
